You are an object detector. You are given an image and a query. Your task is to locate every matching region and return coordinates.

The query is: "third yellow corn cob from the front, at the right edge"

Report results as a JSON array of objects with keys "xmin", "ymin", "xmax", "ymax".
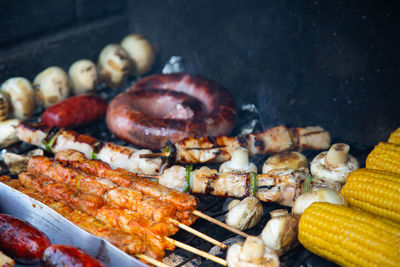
[{"xmin": 365, "ymin": 142, "xmax": 400, "ymax": 174}]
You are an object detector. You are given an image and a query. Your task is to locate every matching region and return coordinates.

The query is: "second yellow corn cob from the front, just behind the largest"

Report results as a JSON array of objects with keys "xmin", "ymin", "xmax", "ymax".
[{"xmin": 341, "ymin": 169, "xmax": 400, "ymax": 224}]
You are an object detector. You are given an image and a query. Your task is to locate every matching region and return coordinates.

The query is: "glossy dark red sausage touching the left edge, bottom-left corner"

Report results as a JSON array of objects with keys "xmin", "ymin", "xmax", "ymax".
[{"xmin": 0, "ymin": 214, "xmax": 51, "ymax": 264}]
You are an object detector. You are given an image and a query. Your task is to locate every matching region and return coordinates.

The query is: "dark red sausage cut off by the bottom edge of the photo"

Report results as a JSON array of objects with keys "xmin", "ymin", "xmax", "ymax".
[{"xmin": 41, "ymin": 245, "xmax": 104, "ymax": 267}]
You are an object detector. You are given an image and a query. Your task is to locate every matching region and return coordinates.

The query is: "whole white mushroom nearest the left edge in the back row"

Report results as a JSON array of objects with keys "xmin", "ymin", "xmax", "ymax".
[{"xmin": 1, "ymin": 77, "xmax": 35, "ymax": 120}]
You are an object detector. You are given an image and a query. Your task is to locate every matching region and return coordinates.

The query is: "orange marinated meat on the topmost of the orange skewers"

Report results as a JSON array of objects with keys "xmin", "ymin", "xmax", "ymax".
[{"xmin": 55, "ymin": 150, "xmax": 199, "ymax": 212}]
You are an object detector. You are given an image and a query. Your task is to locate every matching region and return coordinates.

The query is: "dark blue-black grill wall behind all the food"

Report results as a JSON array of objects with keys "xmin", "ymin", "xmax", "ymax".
[{"xmin": 0, "ymin": 0, "xmax": 400, "ymax": 146}]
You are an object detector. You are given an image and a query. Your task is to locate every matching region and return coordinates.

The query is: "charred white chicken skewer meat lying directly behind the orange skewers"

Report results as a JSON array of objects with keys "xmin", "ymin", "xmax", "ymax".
[{"xmin": 16, "ymin": 122, "xmax": 162, "ymax": 174}]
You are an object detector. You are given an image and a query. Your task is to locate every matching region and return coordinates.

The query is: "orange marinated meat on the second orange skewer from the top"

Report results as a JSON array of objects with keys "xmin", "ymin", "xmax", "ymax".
[{"xmin": 28, "ymin": 157, "xmax": 180, "ymax": 226}]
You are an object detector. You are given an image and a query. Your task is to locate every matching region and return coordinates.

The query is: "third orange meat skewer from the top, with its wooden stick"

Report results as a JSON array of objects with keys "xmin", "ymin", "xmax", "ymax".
[{"xmin": 19, "ymin": 173, "xmax": 226, "ymax": 266}]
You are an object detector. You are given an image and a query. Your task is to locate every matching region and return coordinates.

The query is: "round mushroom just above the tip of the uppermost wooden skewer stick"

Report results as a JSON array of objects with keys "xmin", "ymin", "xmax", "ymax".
[{"xmin": 225, "ymin": 197, "xmax": 263, "ymax": 230}]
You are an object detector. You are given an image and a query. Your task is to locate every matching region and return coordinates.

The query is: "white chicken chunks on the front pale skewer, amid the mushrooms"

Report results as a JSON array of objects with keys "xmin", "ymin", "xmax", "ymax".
[{"xmin": 159, "ymin": 166, "xmax": 309, "ymax": 206}]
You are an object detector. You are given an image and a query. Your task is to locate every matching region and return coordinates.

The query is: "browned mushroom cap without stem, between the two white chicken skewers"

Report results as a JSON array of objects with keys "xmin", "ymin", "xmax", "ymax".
[{"xmin": 262, "ymin": 151, "xmax": 308, "ymax": 173}]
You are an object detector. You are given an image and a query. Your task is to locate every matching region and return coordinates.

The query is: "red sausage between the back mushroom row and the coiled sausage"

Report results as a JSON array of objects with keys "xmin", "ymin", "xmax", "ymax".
[{"xmin": 42, "ymin": 95, "xmax": 107, "ymax": 128}]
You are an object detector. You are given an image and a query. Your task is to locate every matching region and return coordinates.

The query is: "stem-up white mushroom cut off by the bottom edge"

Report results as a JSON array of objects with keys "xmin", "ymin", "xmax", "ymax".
[{"xmin": 226, "ymin": 236, "xmax": 279, "ymax": 267}]
